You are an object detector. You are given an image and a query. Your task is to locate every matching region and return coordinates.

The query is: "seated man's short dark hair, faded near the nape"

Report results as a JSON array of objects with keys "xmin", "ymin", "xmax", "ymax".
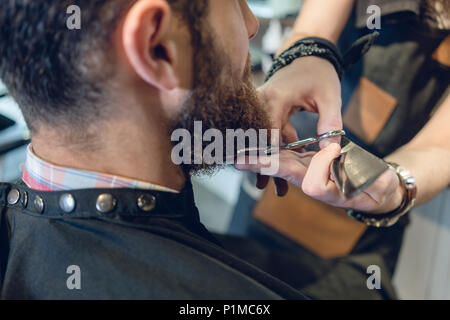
[{"xmin": 0, "ymin": 0, "xmax": 206, "ymax": 131}]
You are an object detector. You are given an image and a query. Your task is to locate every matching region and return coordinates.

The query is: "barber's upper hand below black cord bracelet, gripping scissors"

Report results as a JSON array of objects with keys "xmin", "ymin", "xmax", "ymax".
[{"xmin": 257, "ymin": 57, "xmax": 342, "ymax": 196}]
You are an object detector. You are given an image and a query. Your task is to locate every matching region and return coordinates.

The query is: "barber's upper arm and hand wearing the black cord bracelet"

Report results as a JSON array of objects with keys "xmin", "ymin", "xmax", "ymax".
[{"xmin": 258, "ymin": 0, "xmax": 354, "ymax": 196}]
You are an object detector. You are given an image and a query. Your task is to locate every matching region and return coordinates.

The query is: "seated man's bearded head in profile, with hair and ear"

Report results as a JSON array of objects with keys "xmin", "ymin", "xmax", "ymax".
[{"xmin": 0, "ymin": 0, "xmax": 270, "ymax": 175}]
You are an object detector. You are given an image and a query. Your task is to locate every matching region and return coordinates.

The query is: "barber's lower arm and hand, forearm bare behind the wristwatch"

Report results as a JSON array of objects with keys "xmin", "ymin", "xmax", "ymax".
[{"xmin": 236, "ymin": 92, "xmax": 450, "ymax": 214}]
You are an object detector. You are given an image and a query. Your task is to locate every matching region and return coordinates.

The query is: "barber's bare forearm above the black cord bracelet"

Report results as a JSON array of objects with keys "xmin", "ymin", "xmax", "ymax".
[{"xmin": 281, "ymin": 0, "xmax": 355, "ymax": 51}]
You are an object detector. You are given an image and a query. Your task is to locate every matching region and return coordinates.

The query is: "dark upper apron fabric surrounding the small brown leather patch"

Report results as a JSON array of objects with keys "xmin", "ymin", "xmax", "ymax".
[{"xmin": 340, "ymin": 13, "xmax": 450, "ymax": 157}]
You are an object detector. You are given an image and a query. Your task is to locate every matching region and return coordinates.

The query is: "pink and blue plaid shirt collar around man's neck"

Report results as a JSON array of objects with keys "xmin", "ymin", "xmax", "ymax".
[{"xmin": 22, "ymin": 144, "xmax": 178, "ymax": 193}]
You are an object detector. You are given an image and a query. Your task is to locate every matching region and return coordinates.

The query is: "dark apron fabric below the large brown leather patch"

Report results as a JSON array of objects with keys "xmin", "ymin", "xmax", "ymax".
[{"xmin": 220, "ymin": 220, "xmax": 397, "ymax": 300}]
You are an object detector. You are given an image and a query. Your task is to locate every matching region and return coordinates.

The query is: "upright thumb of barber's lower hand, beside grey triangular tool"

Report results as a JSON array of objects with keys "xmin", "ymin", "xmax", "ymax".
[{"xmin": 302, "ymin": 143, "xmax": 341, "ymax": 199}]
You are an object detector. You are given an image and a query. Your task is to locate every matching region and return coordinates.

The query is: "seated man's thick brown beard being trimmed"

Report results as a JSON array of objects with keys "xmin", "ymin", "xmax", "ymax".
[{"xmin": 171, "ymin": 28, "xmax": 271, "ymax": 175}]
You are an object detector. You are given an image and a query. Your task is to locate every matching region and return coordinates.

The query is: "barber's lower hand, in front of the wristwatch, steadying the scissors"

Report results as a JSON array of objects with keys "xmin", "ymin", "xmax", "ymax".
[{"xmin": 235, "ymin": 143, "xmax": 403, "ymax": 214}]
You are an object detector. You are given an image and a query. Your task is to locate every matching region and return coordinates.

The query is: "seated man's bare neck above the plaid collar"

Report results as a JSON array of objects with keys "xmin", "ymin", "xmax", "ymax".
[{"xmin": 33, "ymin": 117, "xmax": 186, "ymax": 191}]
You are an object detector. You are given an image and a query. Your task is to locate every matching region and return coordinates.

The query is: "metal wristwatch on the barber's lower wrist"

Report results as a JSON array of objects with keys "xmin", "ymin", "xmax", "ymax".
[{"xmin": 347, "ymin": 163, "xmax": 417, "ymax": 228}]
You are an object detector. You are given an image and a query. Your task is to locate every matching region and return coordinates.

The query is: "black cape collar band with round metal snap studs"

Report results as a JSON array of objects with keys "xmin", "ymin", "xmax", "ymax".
[{"xmin": 0, "ymin": 182, "xmax": 199, "ymax": 221}]
